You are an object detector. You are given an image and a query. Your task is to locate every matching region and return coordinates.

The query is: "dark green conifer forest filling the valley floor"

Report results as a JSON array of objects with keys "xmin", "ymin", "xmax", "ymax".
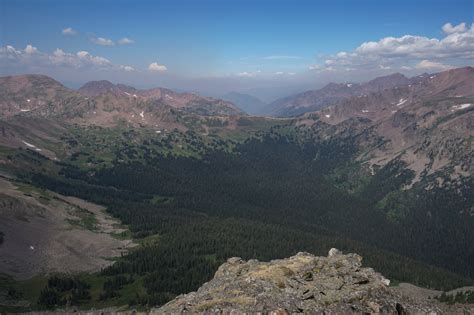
[{"xmin": 20, "ymin": 132, "xmax": 474, "ymax": 305}]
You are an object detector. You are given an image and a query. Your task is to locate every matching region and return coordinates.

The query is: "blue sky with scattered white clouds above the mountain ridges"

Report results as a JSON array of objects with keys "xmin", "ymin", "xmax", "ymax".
[{"xmin": 0, "ymin": 0, "xmax": 474, "ymax": 100}]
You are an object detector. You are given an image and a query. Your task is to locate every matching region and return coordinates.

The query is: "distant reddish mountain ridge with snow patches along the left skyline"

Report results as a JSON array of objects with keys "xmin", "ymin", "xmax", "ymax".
[{"xmin": 0, "ymin": 75, "xmax": 245, "ymax": 129}]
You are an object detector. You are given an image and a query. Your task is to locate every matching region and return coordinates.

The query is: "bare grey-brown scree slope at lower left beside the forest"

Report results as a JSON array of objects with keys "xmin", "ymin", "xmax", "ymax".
[{"xmin": 0, "ymin": 178, "xmax": 132, "ymax": 279}]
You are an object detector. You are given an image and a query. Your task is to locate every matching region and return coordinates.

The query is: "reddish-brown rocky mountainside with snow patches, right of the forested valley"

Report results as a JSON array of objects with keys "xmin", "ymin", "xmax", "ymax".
[{"xmin": 309, "ymin": 67, "xmax": 474, "ymax": 181}]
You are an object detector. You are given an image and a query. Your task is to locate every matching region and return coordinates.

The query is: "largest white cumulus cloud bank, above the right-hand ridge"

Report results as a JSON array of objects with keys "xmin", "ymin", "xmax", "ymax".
[{"xmin": 310, "ymin": 23, "xmax": 474, "ymax": 71}]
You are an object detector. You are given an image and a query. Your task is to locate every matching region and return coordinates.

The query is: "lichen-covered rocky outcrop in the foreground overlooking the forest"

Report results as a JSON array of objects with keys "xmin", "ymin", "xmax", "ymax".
[{"xmin": 156, "ymin": 249, "xmax": 466, "ymax": 314}]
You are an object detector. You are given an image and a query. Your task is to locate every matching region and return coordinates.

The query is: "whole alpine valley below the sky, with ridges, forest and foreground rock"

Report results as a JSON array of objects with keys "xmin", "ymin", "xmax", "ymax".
[{"xmin": 0, "ymin": 67, "xmax": 474, "ymax": 314}]
